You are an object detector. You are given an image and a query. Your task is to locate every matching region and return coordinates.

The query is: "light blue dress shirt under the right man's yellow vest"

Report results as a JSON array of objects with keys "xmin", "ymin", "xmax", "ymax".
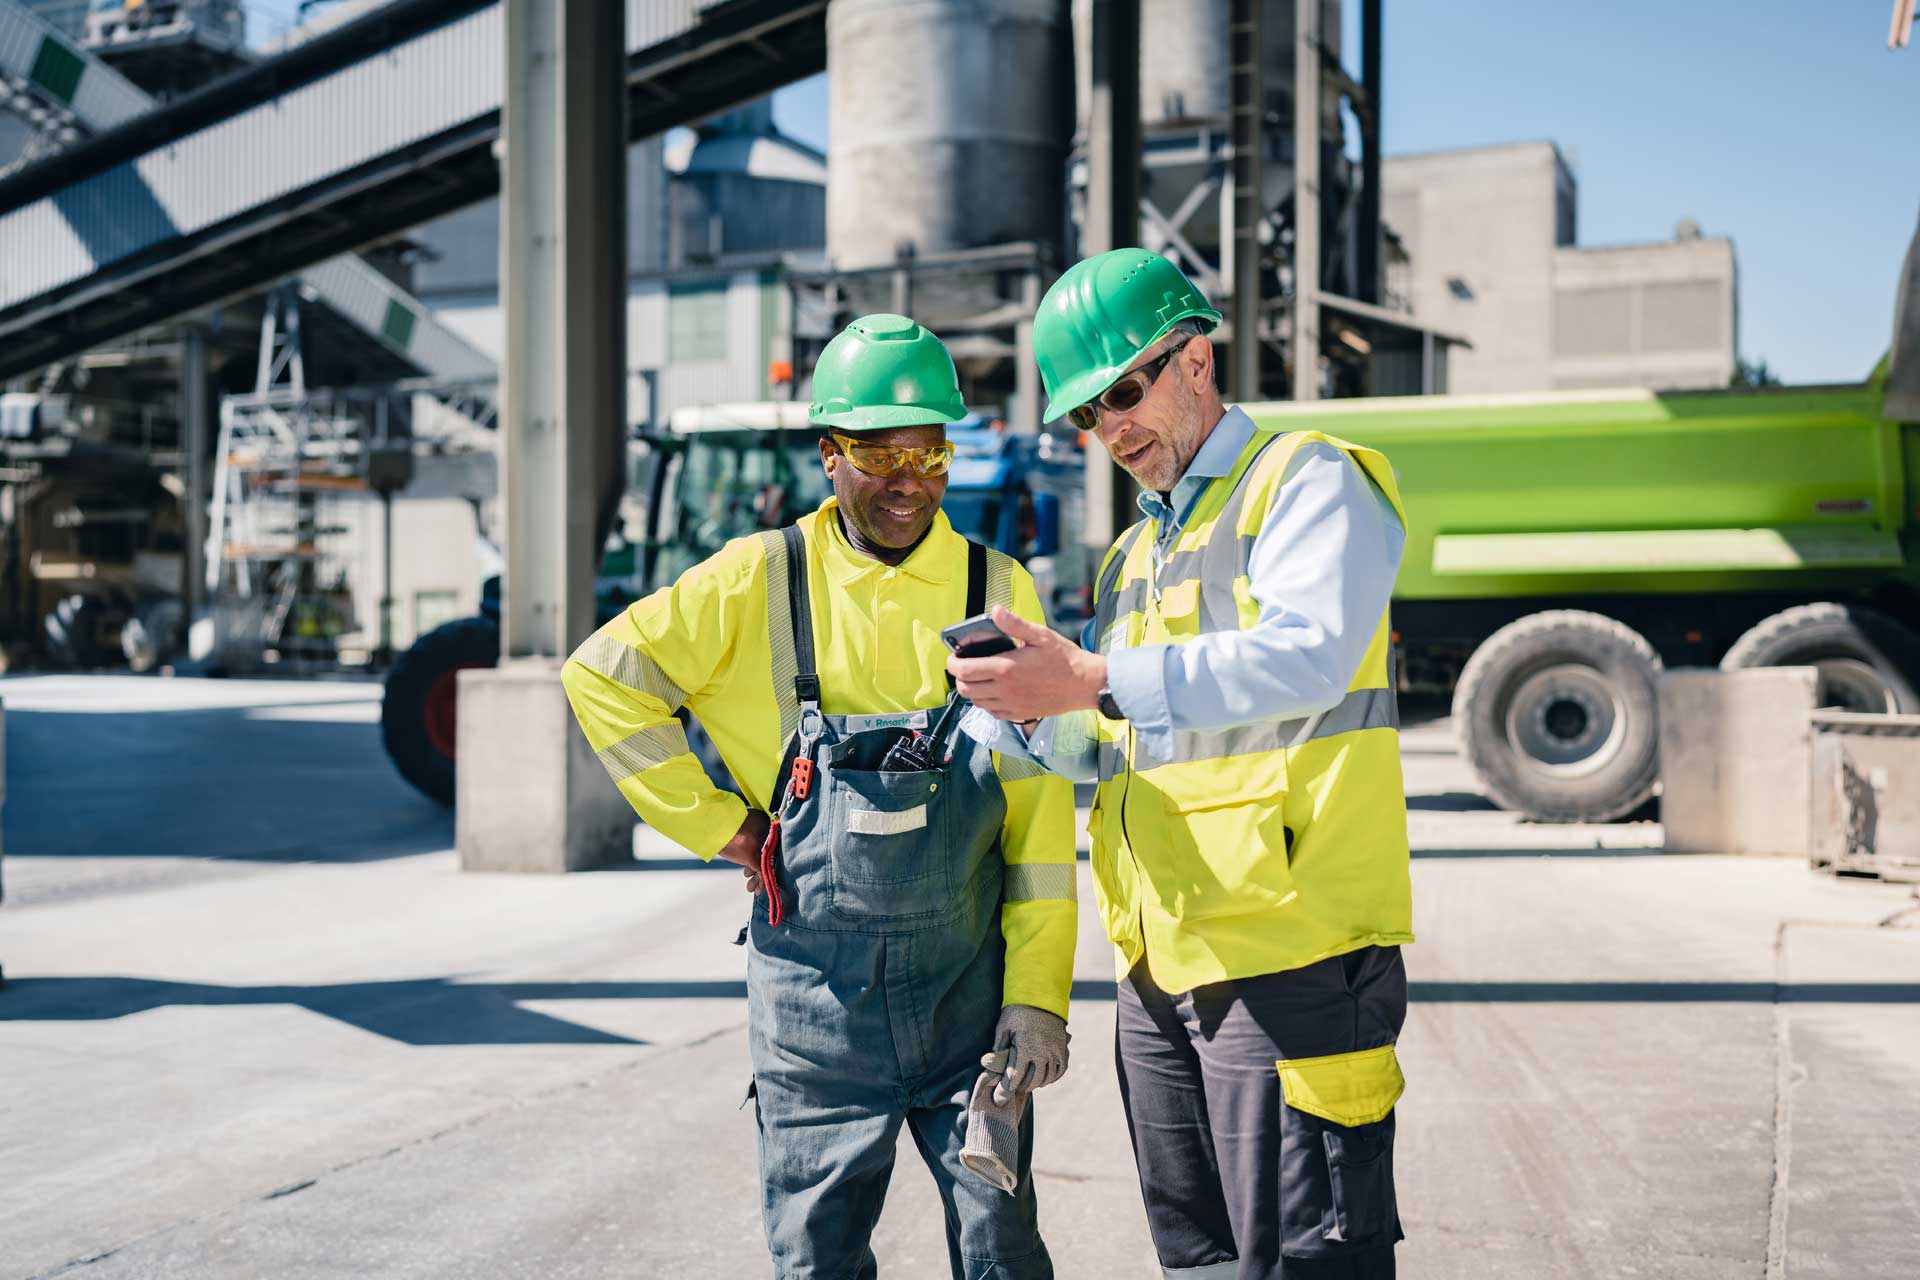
[{"xmin": 962, "ymin": 409, "xmax": 1405, "ymax": 781}]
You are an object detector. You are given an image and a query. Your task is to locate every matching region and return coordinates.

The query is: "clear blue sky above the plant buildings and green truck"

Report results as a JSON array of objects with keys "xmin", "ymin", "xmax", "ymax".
[{"xmin": 774, "ymin": 0, "xmax": 1920, "ymax": 382}]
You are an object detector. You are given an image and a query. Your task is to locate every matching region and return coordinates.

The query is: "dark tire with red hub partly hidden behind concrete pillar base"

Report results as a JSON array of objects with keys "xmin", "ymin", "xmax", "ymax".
[{"xmin": 380, "ymin": 618, "xmax": 499, "ymax": 804}]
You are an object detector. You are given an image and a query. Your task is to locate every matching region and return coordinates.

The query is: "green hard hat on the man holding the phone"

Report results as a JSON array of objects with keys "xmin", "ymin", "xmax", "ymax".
[{"xmin": 1033, "ymin": 249, "xmax": 1219, "ymax": 422}]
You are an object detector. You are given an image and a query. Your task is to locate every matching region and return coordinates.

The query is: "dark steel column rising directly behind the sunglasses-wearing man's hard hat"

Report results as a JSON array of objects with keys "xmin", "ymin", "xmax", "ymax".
[{"xmin": 1081, "ymin": 0, "xmax": 1140, "ymax": 553}]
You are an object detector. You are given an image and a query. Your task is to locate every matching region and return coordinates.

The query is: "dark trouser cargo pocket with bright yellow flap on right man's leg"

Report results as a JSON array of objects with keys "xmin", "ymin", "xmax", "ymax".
[{"xmin": 1275, "ymin": 1044, "xmax": 1405, "ymax": 1257}]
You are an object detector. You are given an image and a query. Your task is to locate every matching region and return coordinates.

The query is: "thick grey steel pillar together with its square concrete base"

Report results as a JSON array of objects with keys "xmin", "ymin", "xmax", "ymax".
[{"xmin": 453, "ymin": 0, "xmax": 634, "ymax": 871}]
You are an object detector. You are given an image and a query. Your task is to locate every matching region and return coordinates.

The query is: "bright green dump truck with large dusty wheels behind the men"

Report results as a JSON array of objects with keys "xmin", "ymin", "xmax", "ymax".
[{"xmin": 1248, "ymin": 226, "xmax": 1920, "ymax": 821}]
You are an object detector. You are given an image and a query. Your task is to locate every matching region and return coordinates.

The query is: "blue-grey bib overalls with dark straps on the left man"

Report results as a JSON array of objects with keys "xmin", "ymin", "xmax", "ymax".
[{"xmin": 747, "ymin": 528, "xmax": 1052, "ymax": 1280}]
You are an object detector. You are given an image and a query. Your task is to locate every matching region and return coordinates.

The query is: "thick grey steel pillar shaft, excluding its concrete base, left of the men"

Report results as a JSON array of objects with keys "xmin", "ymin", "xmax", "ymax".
[{"xmin": 499, "ymin": 0, "xmax": 626, "ymax": 658}]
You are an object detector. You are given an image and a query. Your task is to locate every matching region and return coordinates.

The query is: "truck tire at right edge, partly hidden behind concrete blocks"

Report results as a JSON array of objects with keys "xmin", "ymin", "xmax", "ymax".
[{"xmin": 1720, "ymin": 604, "xmax": 1920, "ymax": 714}]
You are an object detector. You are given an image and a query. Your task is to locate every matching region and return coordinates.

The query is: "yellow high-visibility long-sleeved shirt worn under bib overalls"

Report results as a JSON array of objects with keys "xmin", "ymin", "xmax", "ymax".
[{"xmin": 561, "ymin": 499, "xmax": 1077, "ymax": 1017}]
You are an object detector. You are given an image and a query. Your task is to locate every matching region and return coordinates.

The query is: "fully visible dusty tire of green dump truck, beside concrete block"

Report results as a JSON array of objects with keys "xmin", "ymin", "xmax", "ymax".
[{"xmin": 1453, "ymin": 608, "xmax": 1661, "ymax": 821}]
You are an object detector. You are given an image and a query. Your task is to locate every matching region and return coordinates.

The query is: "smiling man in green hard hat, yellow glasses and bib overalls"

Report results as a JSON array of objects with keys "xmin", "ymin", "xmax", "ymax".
[{"xmin": 563, "ymin": 315, "xmax": 1077, "ymax": 1280}]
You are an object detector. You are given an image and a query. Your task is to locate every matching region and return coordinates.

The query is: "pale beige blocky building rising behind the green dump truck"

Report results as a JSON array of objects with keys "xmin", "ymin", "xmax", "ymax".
[{"xmin": 1380, "ymin": 142, "xmax": 1740, "ymax": 393}]
